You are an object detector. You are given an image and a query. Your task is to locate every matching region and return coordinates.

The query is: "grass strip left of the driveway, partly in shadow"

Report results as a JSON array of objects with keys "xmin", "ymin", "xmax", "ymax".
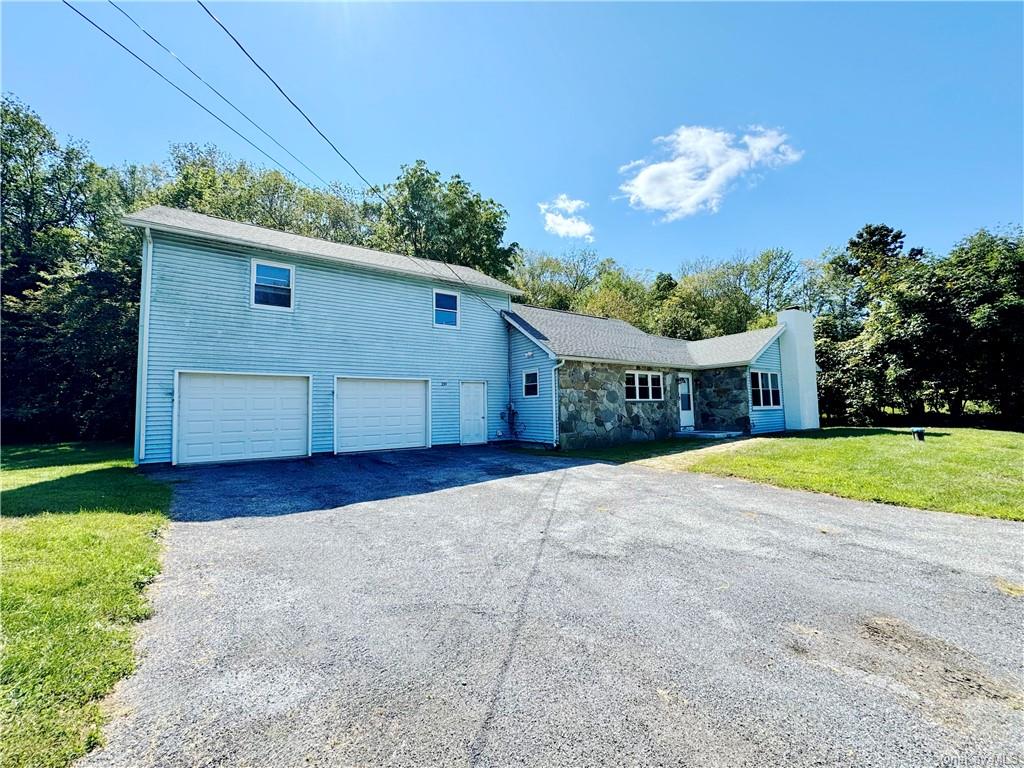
[{"xmin": 0, "ymin": 443, "xmax": 170, "ymax": 768}]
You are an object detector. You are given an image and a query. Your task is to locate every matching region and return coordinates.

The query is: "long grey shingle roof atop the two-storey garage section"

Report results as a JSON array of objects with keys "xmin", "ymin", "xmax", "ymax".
[{"xmin": 122, "ymin": 206, "xmax": 522, "ymax": 295}]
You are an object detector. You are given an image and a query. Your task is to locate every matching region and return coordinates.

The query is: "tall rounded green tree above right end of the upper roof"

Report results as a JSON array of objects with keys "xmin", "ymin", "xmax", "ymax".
[{"xmin": 371, "ymin": 160, "xmax": 520, "ymax": 279}]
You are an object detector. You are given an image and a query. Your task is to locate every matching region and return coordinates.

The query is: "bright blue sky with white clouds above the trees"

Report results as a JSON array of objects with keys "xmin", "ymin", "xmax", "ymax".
[{"xmin": 2, "ymin": 3, "xmax": 1024, "ymax": 270}]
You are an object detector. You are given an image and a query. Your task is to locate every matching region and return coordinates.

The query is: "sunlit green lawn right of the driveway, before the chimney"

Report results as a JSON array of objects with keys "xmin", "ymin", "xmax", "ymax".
[{"xmin": 548, "ymin": 428, "xmax": 1024, "ymax": 520}]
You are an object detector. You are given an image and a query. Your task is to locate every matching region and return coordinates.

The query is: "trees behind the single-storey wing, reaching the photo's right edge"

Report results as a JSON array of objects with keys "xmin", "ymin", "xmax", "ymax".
[{"xmin": 513, "ymin": 224, "xmax": 1024, "ymax": 427}]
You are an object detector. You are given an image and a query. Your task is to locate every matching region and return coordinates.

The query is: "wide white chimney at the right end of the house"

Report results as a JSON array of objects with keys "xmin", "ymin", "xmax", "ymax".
[{"xmin": 778, "ymin": 309, "xmax": 820, "ymax": 429}]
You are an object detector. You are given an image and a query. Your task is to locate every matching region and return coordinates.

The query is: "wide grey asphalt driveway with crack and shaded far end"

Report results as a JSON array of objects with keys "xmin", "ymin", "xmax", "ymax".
[{"xmin": 82, "ymin": 449, "xmax": 1024, "ymax": 768}]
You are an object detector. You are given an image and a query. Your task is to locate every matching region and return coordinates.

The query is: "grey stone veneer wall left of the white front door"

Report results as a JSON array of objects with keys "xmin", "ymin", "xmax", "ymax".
[{"xmin": 558, "ymin": 360, "xmax": 679, "ymax": 449}]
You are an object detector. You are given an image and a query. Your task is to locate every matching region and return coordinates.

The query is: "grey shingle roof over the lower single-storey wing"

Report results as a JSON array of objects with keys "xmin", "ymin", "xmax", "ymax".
[{"xmin": 506, "ymin": 304, "xmax": 782, "ymax": 368}]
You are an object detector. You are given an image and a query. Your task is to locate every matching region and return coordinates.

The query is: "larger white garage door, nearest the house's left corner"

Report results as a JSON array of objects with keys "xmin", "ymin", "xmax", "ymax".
[{"xmin": 176, "ymin": 374, "xmax": 309, "ymax": 464}]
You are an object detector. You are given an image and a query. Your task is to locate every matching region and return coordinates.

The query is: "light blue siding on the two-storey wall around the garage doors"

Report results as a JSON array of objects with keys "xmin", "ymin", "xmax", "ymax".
[{"xmin": 142, "ymin": 232, "xmax": 509, "ymax": 463}]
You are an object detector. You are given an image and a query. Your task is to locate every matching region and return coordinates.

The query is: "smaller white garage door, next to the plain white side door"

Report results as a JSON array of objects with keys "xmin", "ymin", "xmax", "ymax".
[{"xmin": 334, "ymin": 379, "xmax": 427, "ymax": 454}]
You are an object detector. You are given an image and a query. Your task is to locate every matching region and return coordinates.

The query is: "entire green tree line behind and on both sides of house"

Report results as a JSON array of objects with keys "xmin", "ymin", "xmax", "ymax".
[{"xmin": 0, "ymin": 95, "xmax": 1024, "ymax": 440}]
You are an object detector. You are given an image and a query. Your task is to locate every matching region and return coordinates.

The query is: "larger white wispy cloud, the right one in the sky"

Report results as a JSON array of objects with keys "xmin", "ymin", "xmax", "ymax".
[{"xmin": 618, "ymin": 125, "xmax": 804, "ymax": 221}]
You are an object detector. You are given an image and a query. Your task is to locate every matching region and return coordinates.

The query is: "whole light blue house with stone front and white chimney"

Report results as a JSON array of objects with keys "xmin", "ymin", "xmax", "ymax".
[{"xmin": 124, "ymin": 206, "xmax": 818, "ymax": 464}]
